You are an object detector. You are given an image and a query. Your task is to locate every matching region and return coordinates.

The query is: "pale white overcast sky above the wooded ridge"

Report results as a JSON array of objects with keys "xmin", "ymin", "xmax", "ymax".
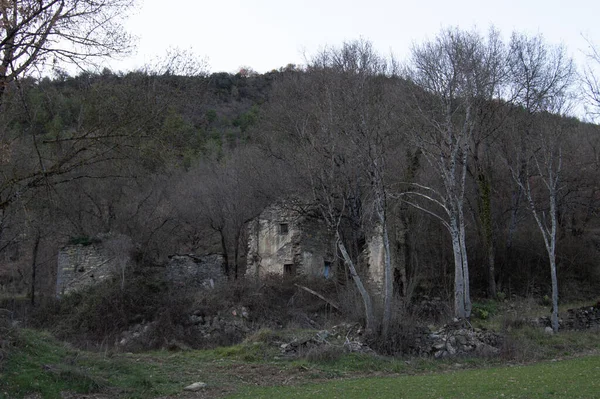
[{"xmin": 110, "ymin": 0, "xmax": 600, "ymax": 72}]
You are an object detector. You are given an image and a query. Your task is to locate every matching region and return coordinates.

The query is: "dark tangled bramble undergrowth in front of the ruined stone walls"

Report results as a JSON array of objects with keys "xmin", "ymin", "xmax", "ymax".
[{"xmin": 27, "ymin": 267, "xmax": 350, "ymax": 352}]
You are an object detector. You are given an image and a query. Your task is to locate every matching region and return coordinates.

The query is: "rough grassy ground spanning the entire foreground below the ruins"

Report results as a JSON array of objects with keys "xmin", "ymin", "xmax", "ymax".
[{"xmin": 0, "ymin": 329, "xmax": 600, "ymax": 398}]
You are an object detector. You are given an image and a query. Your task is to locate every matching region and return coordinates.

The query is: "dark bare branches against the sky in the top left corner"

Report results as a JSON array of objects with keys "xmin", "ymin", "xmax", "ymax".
[{"xmin": 0, "ymin": 0, "xmax": 135, "ymax": 105}]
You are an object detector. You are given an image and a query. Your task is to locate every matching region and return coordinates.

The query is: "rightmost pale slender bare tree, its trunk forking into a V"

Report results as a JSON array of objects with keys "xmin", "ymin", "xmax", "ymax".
[{"xmin": 505, "ymin": 34, "xmax": 575, "ymax": 332}]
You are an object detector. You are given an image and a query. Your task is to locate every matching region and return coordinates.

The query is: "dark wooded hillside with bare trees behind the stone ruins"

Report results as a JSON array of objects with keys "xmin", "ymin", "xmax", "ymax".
[{"xmin": 0, "ymin": 29, "xmax": 599, "ymax": 310}]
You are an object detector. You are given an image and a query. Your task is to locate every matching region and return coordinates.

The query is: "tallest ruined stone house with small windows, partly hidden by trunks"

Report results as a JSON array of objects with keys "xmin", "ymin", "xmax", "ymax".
[{"xmin": 247, "ymin": 203, "xmax": 392, "ymax": 287}]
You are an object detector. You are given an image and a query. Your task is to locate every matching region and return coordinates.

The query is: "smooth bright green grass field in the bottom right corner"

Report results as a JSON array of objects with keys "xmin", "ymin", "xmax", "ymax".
[{"xmin": 231, "ymin": 356, "xmax": 600, "ymax": 399}]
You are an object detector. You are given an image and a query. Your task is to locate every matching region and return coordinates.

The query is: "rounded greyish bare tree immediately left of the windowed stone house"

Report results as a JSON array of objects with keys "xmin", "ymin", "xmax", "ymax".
[{"xmin": 171, "ymin": 146, "xmax": 280, "ymax": 279}]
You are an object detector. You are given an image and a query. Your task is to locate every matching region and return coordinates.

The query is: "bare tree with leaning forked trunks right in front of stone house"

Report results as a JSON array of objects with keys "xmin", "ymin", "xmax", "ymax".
[{"xmin": 263, "ymin": 40, "xmax": 406, "ymax": 333}]
